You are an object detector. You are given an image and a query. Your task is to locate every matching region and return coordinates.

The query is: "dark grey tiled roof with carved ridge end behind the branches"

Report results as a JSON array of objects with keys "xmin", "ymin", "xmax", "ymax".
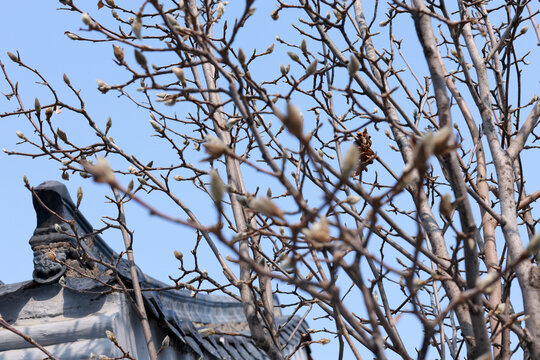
[{"xmin": 21, "ymin": 181, "xmax": 309, "ymax": 359}]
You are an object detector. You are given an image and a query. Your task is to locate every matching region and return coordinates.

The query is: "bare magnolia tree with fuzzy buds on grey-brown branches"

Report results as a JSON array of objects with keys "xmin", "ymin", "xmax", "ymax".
[{"xmin": 1, "ymin": 0, "xmax": 540, "ymax": 359}]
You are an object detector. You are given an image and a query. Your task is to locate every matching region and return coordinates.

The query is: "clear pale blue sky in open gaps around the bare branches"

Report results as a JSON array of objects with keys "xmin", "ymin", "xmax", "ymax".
[{"xmin": 0, "ymin": 0, "xmax": 538, "ymax": 359}]
